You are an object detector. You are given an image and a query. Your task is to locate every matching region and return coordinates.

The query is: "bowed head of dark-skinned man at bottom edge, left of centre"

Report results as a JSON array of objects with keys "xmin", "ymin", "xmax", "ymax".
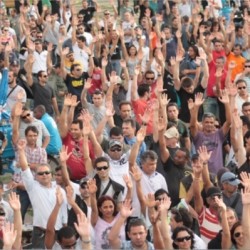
[{"xmin": 57, "ymin": 226, "xmax": 77, "ymax": 249}]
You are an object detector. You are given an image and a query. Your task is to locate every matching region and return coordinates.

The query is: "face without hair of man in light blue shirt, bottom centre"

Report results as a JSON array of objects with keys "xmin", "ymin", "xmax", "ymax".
[{"xmin": 128, "ymin": 226, "xmax": 147, "ymax": 248}]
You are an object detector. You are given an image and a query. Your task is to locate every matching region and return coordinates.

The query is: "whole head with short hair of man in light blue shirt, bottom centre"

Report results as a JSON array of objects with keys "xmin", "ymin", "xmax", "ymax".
[{"xmin": 128, "ymin": 219, "xmax": 147, "ymax": 249}]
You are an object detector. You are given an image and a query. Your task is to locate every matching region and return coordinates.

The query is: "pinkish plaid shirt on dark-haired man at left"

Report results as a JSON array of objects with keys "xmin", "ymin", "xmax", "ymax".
[{"xmin": 12, "ymin": 146, "xmax": 47, "ymax": 183}]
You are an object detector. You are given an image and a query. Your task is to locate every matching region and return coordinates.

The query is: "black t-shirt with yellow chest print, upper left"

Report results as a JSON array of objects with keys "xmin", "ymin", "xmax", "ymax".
[{"xmin": 65, "ymin": 72, "xmax": 89, "ymax": 101}]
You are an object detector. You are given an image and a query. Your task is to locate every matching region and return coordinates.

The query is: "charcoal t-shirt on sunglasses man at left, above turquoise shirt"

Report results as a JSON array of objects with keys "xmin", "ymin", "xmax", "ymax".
[{"xmin": 31, "ymin": 83, "xmax": 55, "ymax": 115}]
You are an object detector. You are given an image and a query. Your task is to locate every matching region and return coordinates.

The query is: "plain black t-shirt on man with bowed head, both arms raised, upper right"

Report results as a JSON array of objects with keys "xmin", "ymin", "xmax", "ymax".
[{"xmin": 177, "ymin": 85, "xmax": 205, "ymax": 123}]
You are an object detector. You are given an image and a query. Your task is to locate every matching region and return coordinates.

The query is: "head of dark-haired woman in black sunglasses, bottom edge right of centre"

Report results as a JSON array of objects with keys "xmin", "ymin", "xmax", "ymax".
[{"xmin": 172, "ymin": 226, "xmax": 194, "ymax": 250}]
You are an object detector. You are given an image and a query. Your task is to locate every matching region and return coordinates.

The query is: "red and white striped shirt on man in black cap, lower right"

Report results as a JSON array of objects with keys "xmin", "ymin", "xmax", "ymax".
[{"xmin": 198, "ymin": 206, "xmax": 221, "ymax": 244}]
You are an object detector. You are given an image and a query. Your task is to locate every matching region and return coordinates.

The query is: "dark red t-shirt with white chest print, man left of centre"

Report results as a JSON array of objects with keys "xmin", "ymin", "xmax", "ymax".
[{"xmin": 62, "ymin": 133, "xmax": 95, "ymax": 180}]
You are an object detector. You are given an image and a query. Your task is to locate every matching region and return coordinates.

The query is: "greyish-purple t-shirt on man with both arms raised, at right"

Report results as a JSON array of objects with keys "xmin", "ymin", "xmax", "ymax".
[{"xmin": 193, "ymin": 129, "xmax": 225, "ymax": 174}]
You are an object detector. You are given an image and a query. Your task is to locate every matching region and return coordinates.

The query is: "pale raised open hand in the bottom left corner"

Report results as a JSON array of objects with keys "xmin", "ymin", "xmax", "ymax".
[{"xmin": 2, "ymin": 222, "xmax": 17, "ymax": 249}]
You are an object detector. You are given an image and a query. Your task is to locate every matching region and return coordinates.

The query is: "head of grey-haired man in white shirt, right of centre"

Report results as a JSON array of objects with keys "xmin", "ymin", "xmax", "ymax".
[{"xmin": 140, "ymin": 150, "xmax": 158, "ymax": 176}]
